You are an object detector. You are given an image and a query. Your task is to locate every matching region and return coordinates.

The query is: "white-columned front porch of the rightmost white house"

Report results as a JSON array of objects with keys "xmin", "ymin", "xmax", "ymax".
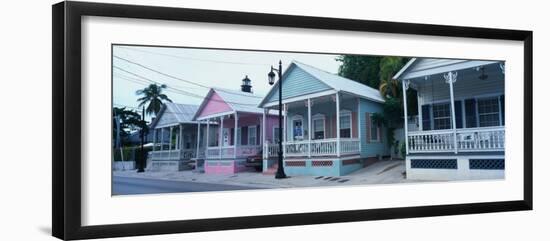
[{"xmin": 397, "ymin": 59, "xmax": 505, "ymax": 154}]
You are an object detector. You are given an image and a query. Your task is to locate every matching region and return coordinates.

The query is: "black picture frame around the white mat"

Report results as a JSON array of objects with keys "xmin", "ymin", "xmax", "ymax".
[{"xmin": 52, "ymin": 2, "xmax": 533, "ymax": 240}]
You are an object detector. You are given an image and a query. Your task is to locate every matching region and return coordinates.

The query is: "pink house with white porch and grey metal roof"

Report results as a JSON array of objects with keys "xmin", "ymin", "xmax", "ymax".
[{"xmin": 194, "ymin": 88, "xmax": 277, "ymax": 174}]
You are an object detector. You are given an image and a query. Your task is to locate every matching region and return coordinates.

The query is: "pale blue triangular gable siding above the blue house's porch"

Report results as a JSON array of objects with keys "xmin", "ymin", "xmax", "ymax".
[{"xmin": 267, "ymin": 67, "xmax": 331, "ymax": 103}]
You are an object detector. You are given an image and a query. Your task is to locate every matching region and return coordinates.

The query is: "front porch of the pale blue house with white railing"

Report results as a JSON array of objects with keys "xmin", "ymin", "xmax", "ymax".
[{"xmin": 262, "ymin": 92, "xmax": 361, "ymax": 159}]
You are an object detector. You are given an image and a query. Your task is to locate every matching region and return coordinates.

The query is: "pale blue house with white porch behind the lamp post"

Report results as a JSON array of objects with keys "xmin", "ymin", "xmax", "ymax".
[{"xmin": 259, "ymin": 61, "xmax": 389, "ymax": 176}]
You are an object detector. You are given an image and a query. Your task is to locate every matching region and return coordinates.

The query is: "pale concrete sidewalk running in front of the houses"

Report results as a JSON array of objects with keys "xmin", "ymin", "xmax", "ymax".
[{"xmin": 113, "ymin": 161, "xmax": 418, "ymax": 188}]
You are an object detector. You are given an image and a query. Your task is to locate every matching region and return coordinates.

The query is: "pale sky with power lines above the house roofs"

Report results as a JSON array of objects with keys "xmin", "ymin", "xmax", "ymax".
[{"xmin": 113, "ymin": 45, "xmax": 340, "ymax": 119}]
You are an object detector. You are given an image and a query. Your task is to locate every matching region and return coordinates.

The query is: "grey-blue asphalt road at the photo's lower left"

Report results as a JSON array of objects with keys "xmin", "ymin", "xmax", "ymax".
[{"xmin": 112, "ymin": 176, "xmax": 257, "ymax": 195}]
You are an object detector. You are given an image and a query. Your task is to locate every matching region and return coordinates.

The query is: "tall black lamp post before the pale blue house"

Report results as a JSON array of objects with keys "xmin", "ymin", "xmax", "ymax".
[{"xmin": 267, "ymin": 60, "xmax": 287, "ymax": 179}]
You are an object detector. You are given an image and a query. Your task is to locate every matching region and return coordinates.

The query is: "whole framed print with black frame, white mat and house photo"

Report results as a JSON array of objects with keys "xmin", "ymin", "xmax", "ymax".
[{"xmin": 52, "ymin": 1, "xmax": 533, "ymax": 239}]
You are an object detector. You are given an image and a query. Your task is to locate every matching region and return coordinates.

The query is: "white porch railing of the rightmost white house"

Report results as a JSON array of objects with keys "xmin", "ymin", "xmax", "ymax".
[{"xmin": 407, "ymin": 127, "xmax": 504, "ymax": 153}]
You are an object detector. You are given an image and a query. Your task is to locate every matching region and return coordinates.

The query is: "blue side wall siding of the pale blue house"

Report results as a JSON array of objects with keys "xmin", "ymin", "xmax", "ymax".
[{"xmin": 359, "ymin": 99, "xmax": 389, "ymax": 158}]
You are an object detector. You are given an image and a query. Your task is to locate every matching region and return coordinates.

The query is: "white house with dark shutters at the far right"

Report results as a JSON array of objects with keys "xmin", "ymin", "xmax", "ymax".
[{"xmin": 394, "ymin": 58, "xmax": 505, "ymax": 180}]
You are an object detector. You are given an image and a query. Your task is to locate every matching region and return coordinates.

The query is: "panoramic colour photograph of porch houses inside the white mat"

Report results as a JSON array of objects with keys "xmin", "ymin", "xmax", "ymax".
[{"xmin": 112, "ymin": 43, "xmax": 505, "ymax": 196}]
